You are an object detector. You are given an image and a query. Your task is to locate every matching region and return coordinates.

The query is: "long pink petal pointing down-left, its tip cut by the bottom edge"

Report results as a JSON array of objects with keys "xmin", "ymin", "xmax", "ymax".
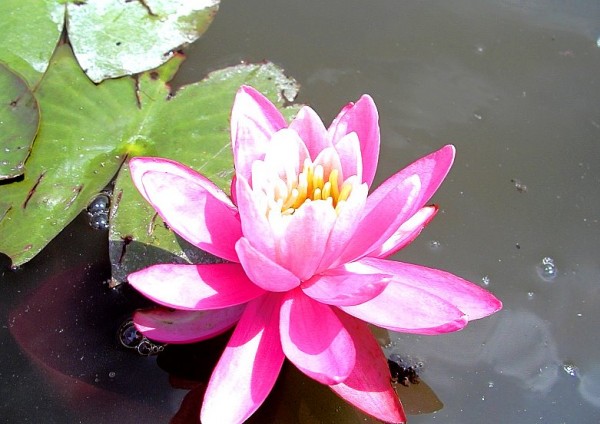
[{"xmin": 200, "ymin": 294, "xmax": 285, "ymax": 424}]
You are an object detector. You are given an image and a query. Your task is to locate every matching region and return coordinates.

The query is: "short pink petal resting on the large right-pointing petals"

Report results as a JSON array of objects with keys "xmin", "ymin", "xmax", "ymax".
[{"xmin": 302, "ymin": 262, "xmax": 390, "ymax": 306}]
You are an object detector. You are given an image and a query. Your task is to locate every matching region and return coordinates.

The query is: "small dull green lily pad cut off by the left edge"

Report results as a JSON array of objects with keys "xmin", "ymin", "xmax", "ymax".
[{"xmin": 0, "ymin": 64, "xmax": 39, "ymax": 180}]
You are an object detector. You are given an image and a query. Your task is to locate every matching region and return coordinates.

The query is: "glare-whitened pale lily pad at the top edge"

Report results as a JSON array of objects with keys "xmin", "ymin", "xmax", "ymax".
[{"xmin": 67, "ymin": 0, "xmax": 219, "ymax": 82}]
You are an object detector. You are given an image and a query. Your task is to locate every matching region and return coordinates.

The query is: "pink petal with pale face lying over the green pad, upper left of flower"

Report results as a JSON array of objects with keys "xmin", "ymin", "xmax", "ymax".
[{"xmin": 129, "ymin": 158, "xmax": 242, "ymax": 262}]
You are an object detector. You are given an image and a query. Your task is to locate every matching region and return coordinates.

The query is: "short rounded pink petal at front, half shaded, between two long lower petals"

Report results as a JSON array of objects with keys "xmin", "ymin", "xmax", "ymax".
[{"xmin": 280, "ymin": 289, "xmax": 356, "ymax": 384}]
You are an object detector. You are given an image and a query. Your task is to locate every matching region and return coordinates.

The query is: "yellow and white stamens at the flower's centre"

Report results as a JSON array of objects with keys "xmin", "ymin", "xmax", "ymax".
[{"xmin": 272, "ymin": 158, "xmax": 352, "ymax": 215}]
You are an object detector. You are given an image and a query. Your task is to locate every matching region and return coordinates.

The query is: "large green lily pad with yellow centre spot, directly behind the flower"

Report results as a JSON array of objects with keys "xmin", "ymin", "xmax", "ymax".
[{"xmin": 0, "ymin": 45, "xmax": 300, "ymax": 266}]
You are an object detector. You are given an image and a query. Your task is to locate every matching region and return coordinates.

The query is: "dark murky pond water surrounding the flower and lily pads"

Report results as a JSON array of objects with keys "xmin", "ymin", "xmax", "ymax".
[{"xmin": 0, "ymin": 0, "xmax": 600, "ymax": 424}]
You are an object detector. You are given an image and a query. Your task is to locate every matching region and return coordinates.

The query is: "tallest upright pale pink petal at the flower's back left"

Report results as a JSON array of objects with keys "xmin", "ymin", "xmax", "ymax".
[{"xmin": 231, "ymin": 86, "xmax": 286, "ymax": 179}]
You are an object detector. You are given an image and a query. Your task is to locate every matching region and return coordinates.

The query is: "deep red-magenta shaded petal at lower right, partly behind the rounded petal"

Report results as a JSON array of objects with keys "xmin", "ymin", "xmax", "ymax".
[{"xmin": 330, "ymin": 311, "xmax": 406, "ymax": 423}]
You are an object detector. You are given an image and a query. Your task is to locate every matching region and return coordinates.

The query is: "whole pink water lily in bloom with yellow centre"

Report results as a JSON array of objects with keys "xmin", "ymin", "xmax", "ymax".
[{"xmin": 128, "ymin": 87, "xmax": 501, "ymax": 424}]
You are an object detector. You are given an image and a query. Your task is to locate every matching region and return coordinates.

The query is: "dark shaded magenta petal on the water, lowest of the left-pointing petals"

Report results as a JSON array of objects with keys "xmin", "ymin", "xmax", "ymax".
[{"xmin": 133, "ymin": 305, "xmax": 246, "ymax": 344}]
